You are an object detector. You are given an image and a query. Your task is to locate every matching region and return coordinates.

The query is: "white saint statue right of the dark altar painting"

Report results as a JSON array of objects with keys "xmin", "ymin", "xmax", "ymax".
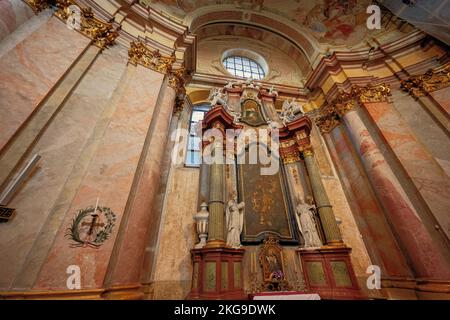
[{"xmin": 296, "ymin": 196, "xmax": 322, "ymax": 248}]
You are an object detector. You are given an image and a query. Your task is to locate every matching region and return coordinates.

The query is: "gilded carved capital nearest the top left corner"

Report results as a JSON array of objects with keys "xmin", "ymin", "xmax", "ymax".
[{"xmin": 51, "ymin": 0, "xmax": 119, "ymax": 49}]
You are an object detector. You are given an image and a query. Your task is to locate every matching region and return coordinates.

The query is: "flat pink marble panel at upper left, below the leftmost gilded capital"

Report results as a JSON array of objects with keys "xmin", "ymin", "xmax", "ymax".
[{"xmin": 0, "ymin": 17, "xmax": 90, "ymax": 151}]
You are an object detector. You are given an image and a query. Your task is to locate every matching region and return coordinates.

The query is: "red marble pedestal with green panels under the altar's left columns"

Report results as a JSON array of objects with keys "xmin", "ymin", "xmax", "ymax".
[{"xmin": 187, "ymin": 247, "xmax": 247, "ymax": 300}]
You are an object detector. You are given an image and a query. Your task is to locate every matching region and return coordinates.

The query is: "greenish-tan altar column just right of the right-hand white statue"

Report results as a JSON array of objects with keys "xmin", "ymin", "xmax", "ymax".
[{"xmin": 300, "ymin": 146, "xmax": 343, "ymax": 246}]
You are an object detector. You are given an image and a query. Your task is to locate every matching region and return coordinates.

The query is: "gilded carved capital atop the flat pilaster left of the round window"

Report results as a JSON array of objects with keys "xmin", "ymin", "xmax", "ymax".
[{"xmin": 128, "ymin": 41, "xmax": 175, "ymax": 74}]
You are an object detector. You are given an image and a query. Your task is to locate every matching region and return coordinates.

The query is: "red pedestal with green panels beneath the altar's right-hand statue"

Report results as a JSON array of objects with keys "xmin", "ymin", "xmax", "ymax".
[{"xmin": 297, "ymin": 246, "xmax": 367, "ymax": 300}]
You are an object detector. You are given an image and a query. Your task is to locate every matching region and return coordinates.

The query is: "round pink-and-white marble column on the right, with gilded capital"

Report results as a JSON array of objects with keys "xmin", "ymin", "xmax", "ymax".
[{"xmin": 338, "ymin": 101, "xmax": 450, "ymax": 279}]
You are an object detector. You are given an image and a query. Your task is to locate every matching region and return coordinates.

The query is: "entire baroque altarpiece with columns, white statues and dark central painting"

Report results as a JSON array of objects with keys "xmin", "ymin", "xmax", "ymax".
[{"xmin": 189, "ymin": 80, "xmax": 362, "ymax": 299}]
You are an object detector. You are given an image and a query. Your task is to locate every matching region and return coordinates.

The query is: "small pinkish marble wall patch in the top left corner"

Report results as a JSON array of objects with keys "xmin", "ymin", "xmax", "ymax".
[{"xmin": 0, "ymin": 0, "xmax": 34, "ymax": 41}]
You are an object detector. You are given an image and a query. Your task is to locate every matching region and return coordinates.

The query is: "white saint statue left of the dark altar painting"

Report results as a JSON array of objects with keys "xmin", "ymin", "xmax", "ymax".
[{"xmin": 226, "ymin": 192, "xmax": 245, "ymax": 248}]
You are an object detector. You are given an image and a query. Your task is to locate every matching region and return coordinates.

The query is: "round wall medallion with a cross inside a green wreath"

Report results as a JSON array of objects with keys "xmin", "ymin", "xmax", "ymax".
[{"xmin": 66, "ymin": 205, "xmax": 117, "ymax": 248}]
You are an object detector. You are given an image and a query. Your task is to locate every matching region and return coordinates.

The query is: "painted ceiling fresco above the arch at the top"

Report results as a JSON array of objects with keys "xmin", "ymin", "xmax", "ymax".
[{"xmin": 144, "ymin": 0, "xmax": 372, "ymax": 45}]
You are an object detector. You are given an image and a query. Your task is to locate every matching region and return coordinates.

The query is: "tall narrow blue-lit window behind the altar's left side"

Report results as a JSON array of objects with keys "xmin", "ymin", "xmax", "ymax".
[{"xmin": 186, "ymin": 105, "xmax": 210, "ymax": 167}]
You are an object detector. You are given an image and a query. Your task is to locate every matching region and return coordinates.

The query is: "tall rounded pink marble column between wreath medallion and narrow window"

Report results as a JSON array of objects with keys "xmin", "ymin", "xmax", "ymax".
[{"xmin": 105, "ymin": 87, "xmax": 175, "ymax": 286}]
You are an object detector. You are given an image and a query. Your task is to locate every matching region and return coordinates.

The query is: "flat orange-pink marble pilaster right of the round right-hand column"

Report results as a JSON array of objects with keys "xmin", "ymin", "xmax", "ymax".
[{"xmin": 366, "ymin": 103, "xmax": 450, "ymax": 245}]
